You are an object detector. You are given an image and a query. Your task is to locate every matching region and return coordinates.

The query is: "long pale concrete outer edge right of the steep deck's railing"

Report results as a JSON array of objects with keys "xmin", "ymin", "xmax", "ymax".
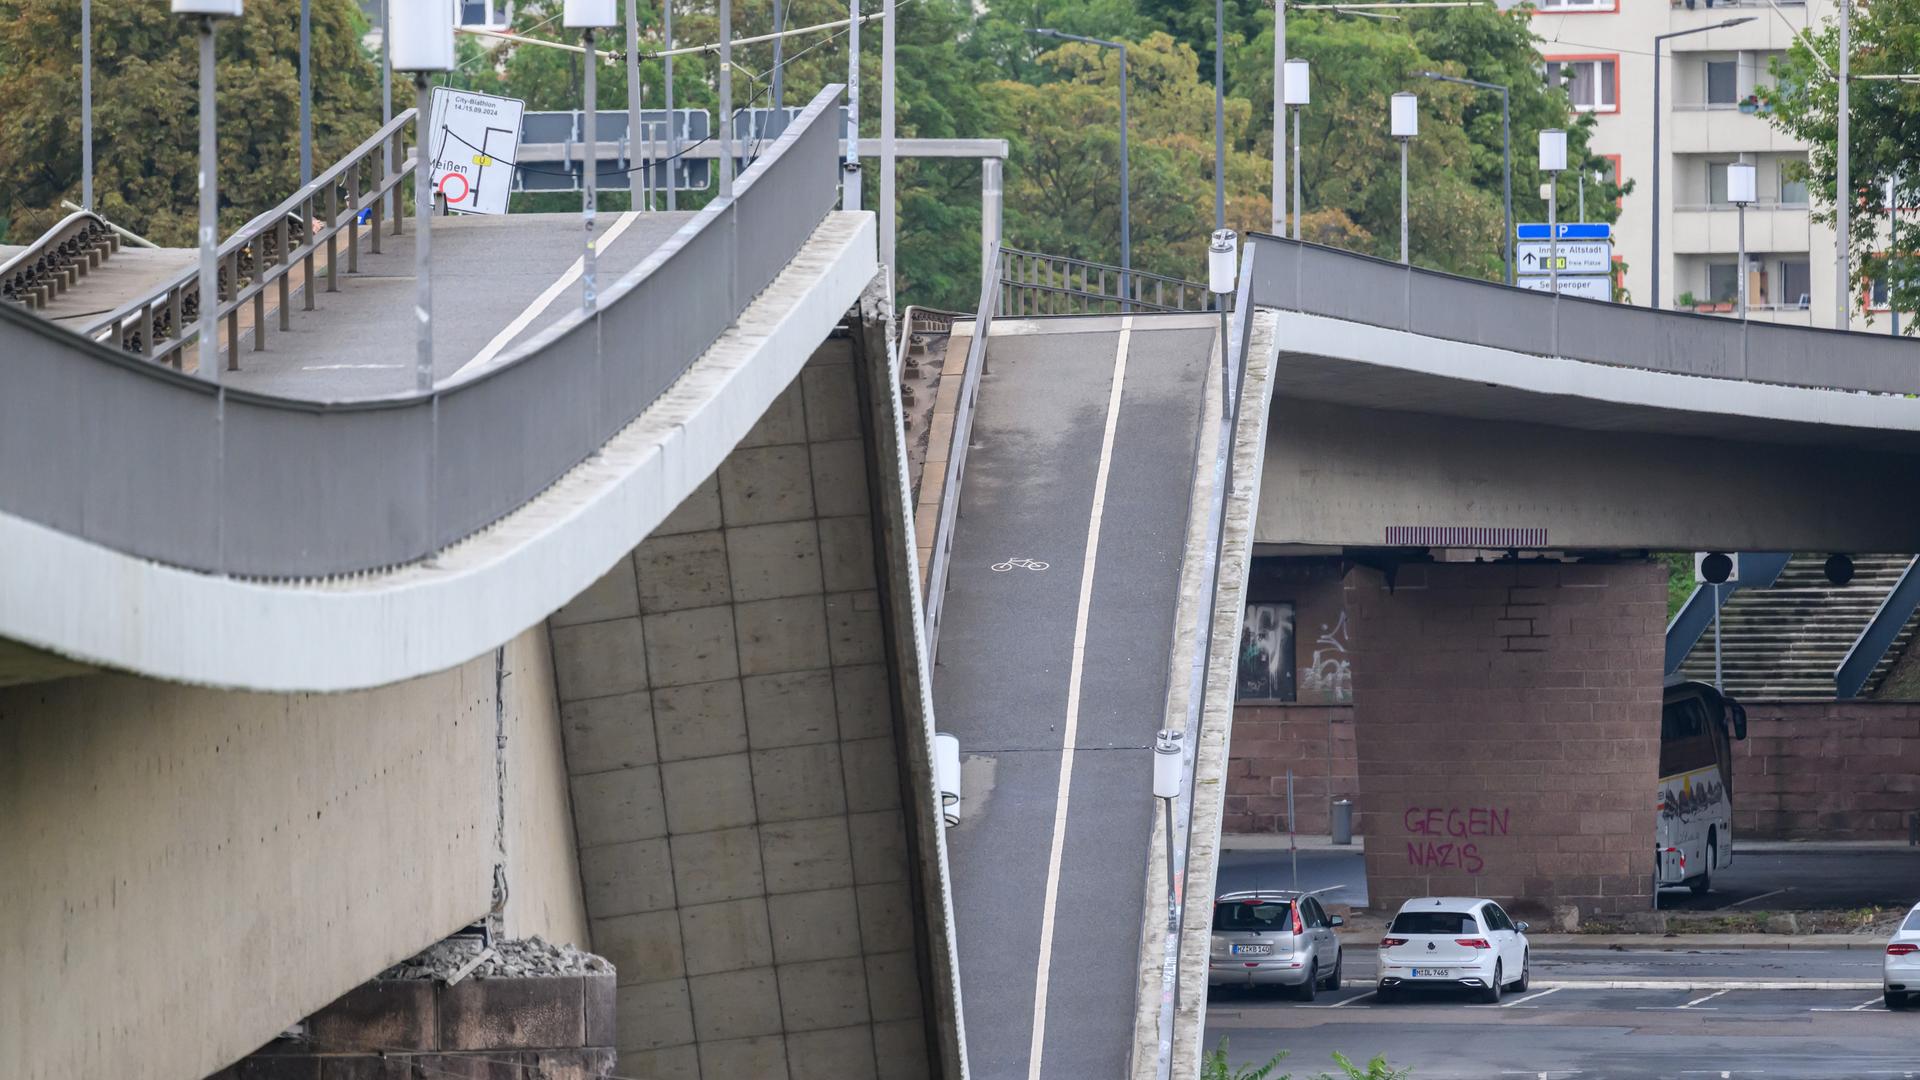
[{"xmin": 1169, "ymin": 309, "xmax": 1279, "ymax": 1080}]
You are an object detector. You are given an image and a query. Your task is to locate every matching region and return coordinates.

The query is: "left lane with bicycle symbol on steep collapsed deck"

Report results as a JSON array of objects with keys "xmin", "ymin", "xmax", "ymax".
[{"xmin": 933, "ymin": 317, "xmax": 1119, "ymax": 1078}]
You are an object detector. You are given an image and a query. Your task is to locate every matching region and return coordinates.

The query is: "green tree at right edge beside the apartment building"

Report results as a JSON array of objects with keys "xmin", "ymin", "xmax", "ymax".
[{"xmin": 1761, "ymin": 0, "xmax": 1920, "ymax": 334}]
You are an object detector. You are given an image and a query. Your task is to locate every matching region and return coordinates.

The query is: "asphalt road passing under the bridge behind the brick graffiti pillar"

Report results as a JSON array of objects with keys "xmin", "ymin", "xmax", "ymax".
[{"xmin": 1217, "ymin": 844, "xmax": 1920, "ymax": 911}]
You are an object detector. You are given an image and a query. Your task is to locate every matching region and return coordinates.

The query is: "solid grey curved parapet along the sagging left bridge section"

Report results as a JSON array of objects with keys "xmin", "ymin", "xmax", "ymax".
[{"xmin": 0, "ymin": 85, "xmax": 841, "ymax": 578}]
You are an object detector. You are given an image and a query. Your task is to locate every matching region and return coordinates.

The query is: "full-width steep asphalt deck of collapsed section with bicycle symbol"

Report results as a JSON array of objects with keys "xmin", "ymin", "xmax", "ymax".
[{"xmin": 933, "ymin": 317, "xmax": 1212, "ymax": 1076}]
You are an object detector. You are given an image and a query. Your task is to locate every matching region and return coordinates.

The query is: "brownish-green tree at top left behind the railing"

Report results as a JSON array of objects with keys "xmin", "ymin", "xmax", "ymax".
[{"xmin": 0, "ymin": 0, "xmax": 380, "ymax": 244}]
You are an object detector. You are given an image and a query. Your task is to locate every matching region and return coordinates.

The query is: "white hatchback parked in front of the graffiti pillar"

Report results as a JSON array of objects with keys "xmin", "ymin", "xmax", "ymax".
[{"xmin": 1377, "ymin": 896, "xmax": 1528, "ymax": 1003}]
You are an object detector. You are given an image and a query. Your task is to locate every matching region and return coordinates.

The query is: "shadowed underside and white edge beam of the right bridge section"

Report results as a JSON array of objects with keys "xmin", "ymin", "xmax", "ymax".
[{"xmin": 1256, "ymin": 313, "xmax": 1920, "ymax": 552}]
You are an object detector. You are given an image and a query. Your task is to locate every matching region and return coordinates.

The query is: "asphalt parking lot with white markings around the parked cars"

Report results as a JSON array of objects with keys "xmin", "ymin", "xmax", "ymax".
[{"xmin": 1208, "ymin": 949, "xmax": 1920, "ymax": 1080}]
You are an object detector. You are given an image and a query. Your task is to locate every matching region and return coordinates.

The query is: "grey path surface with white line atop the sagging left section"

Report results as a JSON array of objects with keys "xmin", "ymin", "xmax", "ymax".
[{"xmin": 226, "ymin": 211, "xmax": 693, "ymax": 402}]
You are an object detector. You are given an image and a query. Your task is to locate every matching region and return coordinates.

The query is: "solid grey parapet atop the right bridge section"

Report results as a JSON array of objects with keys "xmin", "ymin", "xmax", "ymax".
[{"xmin": 1248, "ymin": 233, "xmax": 1920, "ymax": 394}]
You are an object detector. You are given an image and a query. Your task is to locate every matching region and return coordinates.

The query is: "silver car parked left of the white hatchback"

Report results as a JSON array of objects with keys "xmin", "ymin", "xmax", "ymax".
[{"xmin": 1208, "ymin": 892, "xmax": 1346, "ymax": 1001}]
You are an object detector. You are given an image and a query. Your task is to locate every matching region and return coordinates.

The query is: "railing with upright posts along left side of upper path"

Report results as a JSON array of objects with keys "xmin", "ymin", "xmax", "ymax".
[{"xmin": 83, "ymin": 110, "xmax": 420, "ymax": 371}]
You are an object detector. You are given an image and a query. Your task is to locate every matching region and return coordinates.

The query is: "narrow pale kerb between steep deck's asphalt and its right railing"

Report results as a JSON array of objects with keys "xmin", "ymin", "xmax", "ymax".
[{"xmin": 1127, "ymin": 311, "xmax": 1221, "ymax": 1080}]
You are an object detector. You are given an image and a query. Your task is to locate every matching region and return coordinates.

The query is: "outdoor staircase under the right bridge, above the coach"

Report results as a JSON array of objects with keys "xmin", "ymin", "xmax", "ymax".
[{"xmin": 1680, "ymin": 553, "xmax": 1920, "ymax": 701}]
